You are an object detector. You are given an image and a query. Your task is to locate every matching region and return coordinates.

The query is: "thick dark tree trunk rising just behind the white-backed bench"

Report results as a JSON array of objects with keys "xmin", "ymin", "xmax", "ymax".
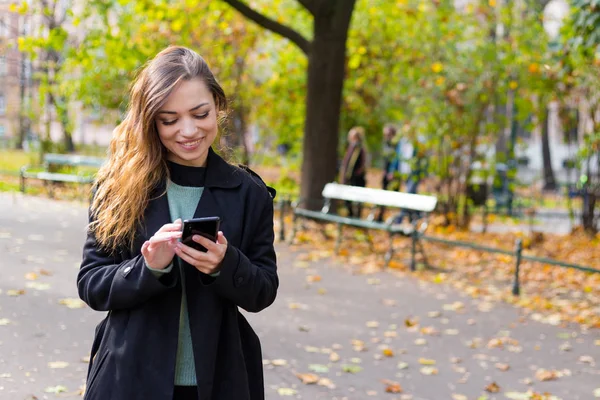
[{"xmin": 300, "ymin": 0, "xmax": 355, "ymax": 208}]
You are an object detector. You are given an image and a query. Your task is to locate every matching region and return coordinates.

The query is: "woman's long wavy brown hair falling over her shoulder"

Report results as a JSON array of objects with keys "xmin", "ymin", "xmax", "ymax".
[{"xmin": 89, "ymin": 46, "xmax": 227, "ymax": 251}]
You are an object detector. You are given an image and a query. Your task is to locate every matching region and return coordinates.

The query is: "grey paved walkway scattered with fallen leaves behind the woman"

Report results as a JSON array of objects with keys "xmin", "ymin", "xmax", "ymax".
[{"xmin": 0, "ymin": 194, "xmax": 600, "ymax": 400}]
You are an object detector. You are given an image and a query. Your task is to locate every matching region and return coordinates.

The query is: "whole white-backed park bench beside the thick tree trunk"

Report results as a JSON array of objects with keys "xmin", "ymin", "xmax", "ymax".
[{"xmin": 290, "ymin": 183, "xmax": 437, "ymax": 265}]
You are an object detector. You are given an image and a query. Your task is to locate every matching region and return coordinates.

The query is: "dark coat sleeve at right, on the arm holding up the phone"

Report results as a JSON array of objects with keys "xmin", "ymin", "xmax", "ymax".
[{"xmin": 211, "ymin": 191, "xmax": 279, "ymax": 312}]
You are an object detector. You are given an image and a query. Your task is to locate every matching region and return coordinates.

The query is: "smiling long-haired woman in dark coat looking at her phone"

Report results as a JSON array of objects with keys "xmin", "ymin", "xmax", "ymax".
[{"xmin": 77, "ymin": 47, "xmax": 279, "ymax": 400}]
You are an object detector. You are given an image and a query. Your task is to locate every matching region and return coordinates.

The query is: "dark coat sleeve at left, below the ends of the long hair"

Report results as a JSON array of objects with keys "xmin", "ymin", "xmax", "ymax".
[{"xmin": 77, "ymin": 211, "xmax": 177, "ymax": 311}]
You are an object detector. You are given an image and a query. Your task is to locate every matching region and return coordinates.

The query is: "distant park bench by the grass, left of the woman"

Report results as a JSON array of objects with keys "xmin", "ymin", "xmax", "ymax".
[{"xmin": 20, "ymin": 153, "xmax": 105, "ymax": 196}]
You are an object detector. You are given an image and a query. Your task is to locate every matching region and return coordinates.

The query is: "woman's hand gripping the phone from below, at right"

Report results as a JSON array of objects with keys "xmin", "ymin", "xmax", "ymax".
[{"xmin": 175, "ymin": 231, "xmax": 227, "ymax": 275}]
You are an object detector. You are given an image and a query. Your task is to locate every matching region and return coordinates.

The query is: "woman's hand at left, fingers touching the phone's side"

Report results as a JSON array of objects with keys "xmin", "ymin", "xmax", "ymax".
[{"xmin": 142, "ymin": 219, "xmax": 181, "ymax": 270}]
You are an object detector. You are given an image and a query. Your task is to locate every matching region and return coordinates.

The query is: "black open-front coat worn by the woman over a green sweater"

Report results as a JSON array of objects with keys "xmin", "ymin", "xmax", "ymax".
[{"xmin": 77, "ymin": 150, "xmax": 279, "ymax": 400}]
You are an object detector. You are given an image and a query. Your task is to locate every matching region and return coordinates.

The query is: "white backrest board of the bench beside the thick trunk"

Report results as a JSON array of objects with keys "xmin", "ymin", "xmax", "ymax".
[{"xmin": 322, "ymin": 183, "xmax": 437, "ymax": 212}]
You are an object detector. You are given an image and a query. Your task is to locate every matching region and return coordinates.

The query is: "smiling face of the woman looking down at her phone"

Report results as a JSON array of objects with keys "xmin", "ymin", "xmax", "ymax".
[{"xmin": 156, "ymin": 78, "xmax": 218, "ymax": 167}]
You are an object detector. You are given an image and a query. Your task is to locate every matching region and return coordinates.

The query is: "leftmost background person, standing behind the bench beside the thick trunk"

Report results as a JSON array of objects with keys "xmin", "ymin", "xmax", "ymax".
[{"xmin": 340, "ymin": 126, "xmax": 368, "ymax": 218}]
